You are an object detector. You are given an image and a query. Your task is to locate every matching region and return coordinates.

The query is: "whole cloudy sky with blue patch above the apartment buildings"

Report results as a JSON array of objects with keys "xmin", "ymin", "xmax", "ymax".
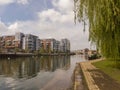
[{"xmin": 0, "ymin": 0, "xmax": 90, "ymax": 50}]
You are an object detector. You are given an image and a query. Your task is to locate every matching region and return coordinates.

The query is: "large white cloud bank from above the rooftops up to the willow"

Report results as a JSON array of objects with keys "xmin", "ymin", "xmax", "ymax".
[{"xmin": 0, "ymin": 0, "xmax": 89, "ymax": 50}]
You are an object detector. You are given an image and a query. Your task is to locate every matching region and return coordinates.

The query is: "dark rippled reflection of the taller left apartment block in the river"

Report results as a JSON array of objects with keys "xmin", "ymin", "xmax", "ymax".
[{"xmin": 0, "ymin": 58, "xmax": 40, "ymax": 78}]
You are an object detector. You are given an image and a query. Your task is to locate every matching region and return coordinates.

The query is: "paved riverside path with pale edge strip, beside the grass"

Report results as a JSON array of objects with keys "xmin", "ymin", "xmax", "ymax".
[{"xmin": 80, "ymin": 60, "xmax": 120, "ymax": 90}]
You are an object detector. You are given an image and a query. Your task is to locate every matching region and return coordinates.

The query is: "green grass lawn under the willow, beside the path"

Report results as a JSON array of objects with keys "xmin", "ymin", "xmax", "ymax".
[{"xmin": 92, "ymin": 60, "xmax": 120, "ymax": 83}]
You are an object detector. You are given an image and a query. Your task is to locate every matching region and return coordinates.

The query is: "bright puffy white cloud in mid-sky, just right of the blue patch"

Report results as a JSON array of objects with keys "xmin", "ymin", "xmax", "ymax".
[{"xmin": 38, "ymin": 9, "xmax": 74, "ymax": 23}]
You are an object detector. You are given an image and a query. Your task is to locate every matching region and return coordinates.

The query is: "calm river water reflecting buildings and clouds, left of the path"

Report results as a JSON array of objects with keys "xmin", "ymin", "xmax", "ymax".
[{"xmin": 0, "ymin": 55, "xmax": 84, "ymax": 90}]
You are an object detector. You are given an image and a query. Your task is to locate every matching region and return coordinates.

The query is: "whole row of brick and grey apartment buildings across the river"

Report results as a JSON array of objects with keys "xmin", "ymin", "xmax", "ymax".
[{"xmin": 0, "ymin": 32, "xmax": 70, "ymax": 53}]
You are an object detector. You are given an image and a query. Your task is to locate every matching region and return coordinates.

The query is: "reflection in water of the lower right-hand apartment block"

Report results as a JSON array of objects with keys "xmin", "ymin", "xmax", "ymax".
[{"xmin": 41, "ymin": 56, "xmax": 70, "ymax": 71}]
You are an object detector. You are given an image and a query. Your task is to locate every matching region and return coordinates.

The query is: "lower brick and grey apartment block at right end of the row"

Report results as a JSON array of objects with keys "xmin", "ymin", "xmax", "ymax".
[{"xmin": 41, "ymin": 39, "xmax": 70, "ymax": 53}]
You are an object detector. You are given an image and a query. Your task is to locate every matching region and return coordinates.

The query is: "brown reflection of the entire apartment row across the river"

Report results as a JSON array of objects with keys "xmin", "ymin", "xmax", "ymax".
[{"xmin": 0, "ymin": 56, "xmax": 70, "ymax": 78}]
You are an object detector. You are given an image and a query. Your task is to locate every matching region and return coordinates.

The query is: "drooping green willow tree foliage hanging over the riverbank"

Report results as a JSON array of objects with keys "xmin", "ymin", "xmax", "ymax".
[{"xmin": 74, "ymin": 0, "xmax": 120, "ymax": 59}]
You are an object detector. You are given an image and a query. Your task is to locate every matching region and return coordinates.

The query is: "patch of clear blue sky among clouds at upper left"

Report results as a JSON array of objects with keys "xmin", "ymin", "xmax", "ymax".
[{"xmin": 0, "ymin": 0, "xmax": 52, "ymax": 23}]
